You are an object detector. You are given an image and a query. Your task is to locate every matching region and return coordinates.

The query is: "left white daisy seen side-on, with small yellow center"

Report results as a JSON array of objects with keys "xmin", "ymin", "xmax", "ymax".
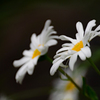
[{"xmin": 13, "ymin": 20, "xmax": 58, "ymax": 83}]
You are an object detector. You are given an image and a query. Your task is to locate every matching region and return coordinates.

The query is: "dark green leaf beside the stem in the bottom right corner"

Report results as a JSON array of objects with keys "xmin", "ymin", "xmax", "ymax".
[{"xmin": 82, "ymin": 77, "xmax": 99, "ymax": 100}]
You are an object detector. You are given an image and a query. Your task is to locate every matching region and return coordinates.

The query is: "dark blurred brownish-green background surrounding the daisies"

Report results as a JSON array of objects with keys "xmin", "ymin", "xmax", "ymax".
[{"xmin": 0, "ymin": 0, "xmax": 100, "ymax": 100}]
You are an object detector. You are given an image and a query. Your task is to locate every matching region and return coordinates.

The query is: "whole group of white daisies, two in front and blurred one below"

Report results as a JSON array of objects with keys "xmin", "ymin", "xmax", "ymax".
[{"xmin": 13, "ymin": 20, "xmax": 100, "ymax": 100}]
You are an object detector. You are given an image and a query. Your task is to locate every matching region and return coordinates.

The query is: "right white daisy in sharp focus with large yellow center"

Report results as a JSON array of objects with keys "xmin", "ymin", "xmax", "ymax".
[{"xmin": 50, "ymin": 20, "xmax": 99, "ymax": 75}]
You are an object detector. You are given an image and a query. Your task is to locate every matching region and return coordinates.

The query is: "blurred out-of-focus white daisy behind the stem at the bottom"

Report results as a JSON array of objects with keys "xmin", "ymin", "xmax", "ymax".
[{"xmin": 49, "ymin": 68, "xmax": 86, "ymax": 100}]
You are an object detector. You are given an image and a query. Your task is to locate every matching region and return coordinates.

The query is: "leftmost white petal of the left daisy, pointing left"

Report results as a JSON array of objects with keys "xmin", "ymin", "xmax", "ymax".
[{"xmin": 13, "ymin": 57, "xmax": 31, "ymax": 67}]
